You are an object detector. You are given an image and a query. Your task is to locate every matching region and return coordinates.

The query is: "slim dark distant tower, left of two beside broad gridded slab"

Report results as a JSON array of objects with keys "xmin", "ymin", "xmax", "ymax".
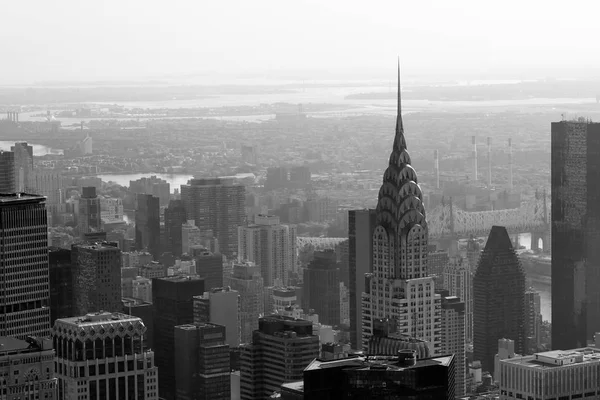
[{"xmin": 135, "ymin": 194, "xmax": 161, "ymax": 260}]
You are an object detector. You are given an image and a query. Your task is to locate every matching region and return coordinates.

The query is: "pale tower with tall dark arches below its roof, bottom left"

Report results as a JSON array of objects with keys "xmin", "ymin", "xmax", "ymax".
[{"xmin": 53, "ymin": 312, "xmax": 158, "ymax": 400}]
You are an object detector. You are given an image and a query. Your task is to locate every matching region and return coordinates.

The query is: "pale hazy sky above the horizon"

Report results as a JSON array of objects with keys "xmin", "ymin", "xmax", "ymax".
[{"xmin": 0, "ymin": 0, "xmax": 600, "ymax": 83}]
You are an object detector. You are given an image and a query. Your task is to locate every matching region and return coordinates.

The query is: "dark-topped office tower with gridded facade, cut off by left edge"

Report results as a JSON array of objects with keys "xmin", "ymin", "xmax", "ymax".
[{"xmin": 0, "ymin": 193, "xmax": 51, "ymax": 339}]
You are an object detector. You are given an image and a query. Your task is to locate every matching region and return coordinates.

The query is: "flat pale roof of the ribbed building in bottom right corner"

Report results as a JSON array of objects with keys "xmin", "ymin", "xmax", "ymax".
[{"xmin": 501, "ymin": 347, "xmax": 600, "ymax": 369}]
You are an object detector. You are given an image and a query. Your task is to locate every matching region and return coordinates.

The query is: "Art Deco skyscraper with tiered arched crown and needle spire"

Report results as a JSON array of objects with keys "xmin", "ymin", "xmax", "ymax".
[{"xmin": 362, "ymin": 71, "xmax": 441, "ymax": 355}]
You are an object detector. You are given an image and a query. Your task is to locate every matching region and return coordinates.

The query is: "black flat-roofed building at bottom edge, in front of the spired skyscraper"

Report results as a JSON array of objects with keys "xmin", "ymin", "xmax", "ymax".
[{"xmin": 304, "ymin": 350, "xmax": 456, "ymax": 400}]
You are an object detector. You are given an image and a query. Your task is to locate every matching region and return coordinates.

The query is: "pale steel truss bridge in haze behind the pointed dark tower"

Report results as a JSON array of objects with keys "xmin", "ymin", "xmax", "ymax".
[{"xmin": 427, "ymin": 192, "xmax": 550, "ymax": 250}]
